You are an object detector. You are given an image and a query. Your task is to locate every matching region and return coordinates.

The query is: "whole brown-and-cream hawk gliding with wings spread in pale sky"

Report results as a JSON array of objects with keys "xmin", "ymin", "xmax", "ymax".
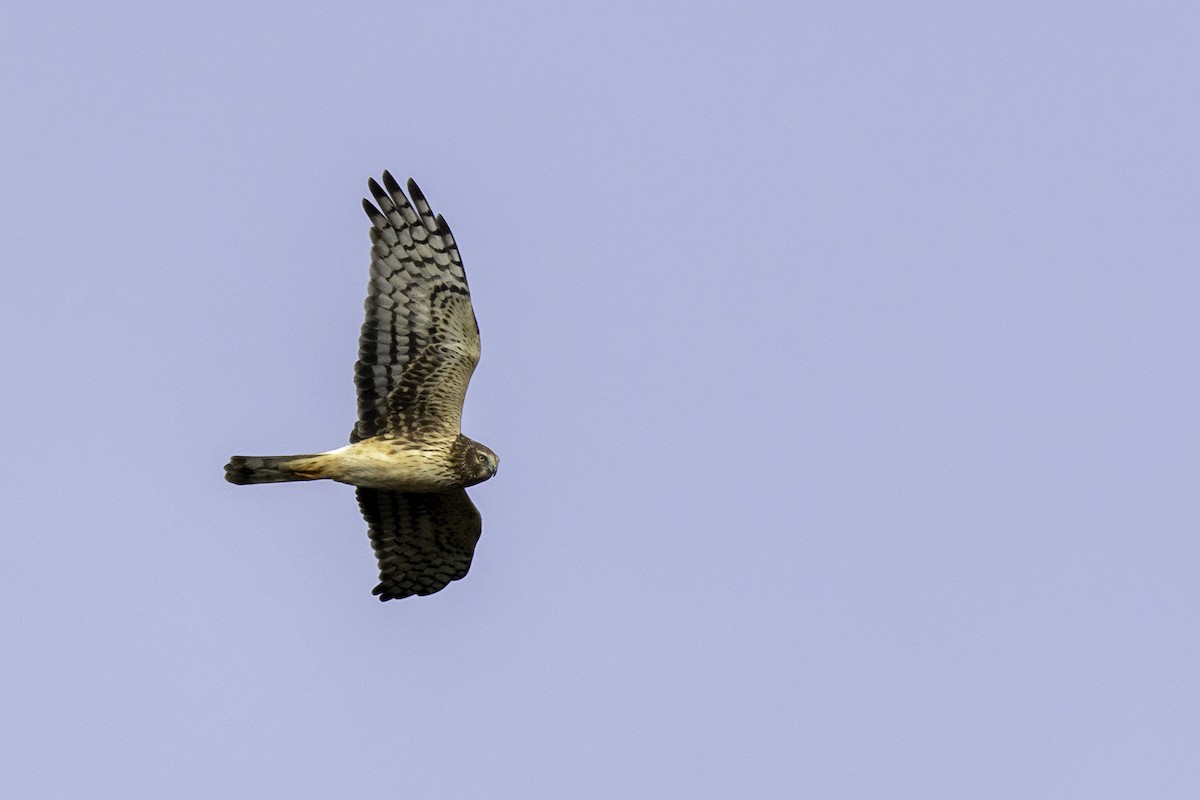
[{"xmin": 226, "ymin": 172, "xmax": 499, "ymax": 600}]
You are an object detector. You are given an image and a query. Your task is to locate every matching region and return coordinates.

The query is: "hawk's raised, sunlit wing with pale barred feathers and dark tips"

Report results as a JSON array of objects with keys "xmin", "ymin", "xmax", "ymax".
[{"xmin": 350, "ymin": 172, "xmax": 479, "ymax": 441}]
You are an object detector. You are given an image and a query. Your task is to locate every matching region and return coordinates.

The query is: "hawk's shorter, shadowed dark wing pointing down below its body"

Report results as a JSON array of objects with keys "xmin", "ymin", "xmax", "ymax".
[{"xmin": 358, "ymin": 488, "xmax": 484, "ymax": 600}]
